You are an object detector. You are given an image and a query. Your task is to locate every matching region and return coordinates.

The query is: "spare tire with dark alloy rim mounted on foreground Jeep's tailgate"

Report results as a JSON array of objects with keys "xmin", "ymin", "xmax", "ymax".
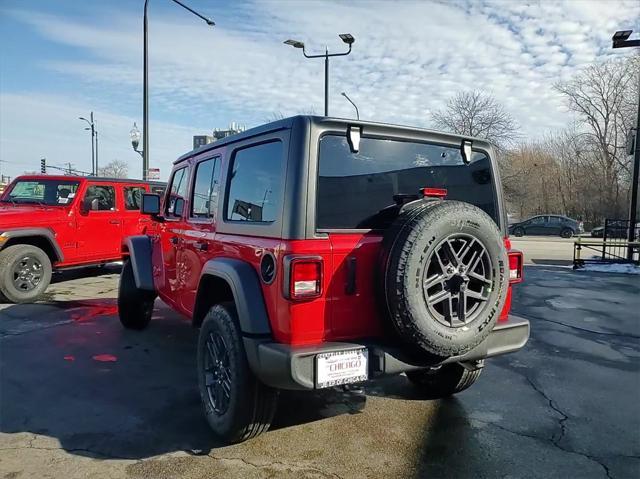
[{"xmin": 382, "ymin": 201, "xmax": 509, "ymax": 357}]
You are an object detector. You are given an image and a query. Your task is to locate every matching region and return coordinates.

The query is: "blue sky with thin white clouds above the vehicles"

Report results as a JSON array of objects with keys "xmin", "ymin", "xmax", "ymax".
[{"xmin": 0, "ymin": 0, "xmax": 640, "ymax": 180}]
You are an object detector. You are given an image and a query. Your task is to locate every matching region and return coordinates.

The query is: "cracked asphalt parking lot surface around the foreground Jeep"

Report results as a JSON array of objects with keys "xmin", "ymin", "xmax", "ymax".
[{"xmin": 0, "ymin": 266, "xmax": 640, "ymax": 479}]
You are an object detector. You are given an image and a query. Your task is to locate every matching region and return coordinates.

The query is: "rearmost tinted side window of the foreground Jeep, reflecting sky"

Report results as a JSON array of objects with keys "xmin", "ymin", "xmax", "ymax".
[{"xmin": 225, "ymin": 141, "xmax": 284, "ymax": 222}]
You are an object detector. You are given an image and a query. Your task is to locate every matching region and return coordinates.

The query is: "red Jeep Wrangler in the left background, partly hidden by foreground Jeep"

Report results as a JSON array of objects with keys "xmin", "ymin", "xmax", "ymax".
[{"xmin": 0, "ymin": 175, "xmax": 164, "ymax": 303}]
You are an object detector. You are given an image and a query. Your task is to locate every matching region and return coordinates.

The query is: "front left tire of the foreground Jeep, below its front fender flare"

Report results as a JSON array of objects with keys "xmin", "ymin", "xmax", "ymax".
[{"xmin": 118, "ymin": 259, "xmax": 156, "ymax": 331}]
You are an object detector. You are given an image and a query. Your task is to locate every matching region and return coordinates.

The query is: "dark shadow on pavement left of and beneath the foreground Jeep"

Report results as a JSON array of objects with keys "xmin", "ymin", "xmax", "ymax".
[{"xmin": 0, "ymin": 299, "xmax": 378, "ymax": 459}]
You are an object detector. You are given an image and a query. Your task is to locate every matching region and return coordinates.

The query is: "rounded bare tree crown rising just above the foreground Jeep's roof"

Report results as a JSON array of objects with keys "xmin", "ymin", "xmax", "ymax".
[{"xmin": 432, "ymin": 91, "xmax": 520, "ymax": 151}]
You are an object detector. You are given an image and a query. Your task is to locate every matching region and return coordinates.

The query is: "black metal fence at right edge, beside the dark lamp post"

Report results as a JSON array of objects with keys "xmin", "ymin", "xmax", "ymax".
[{"xmin": 573, "ymin": 219, "xmax": 640, "ymax": 268}]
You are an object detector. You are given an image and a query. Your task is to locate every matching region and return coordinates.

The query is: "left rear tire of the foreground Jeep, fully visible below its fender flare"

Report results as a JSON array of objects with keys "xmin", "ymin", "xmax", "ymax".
[{"xmin": 198, "ymin": 303, "xmax": 278, "ymax": 444}]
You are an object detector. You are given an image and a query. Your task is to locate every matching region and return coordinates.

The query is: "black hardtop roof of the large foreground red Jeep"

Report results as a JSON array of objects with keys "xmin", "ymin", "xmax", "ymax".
[{"xmin": 173, "ymin": 115, "xmax": 491, "ymax": 165}]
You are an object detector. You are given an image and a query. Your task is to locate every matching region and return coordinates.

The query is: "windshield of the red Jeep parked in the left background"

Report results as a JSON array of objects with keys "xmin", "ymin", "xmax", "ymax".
[{"xmin": 2, "ymin": 179, "xmax": 80, "ymax": 206}]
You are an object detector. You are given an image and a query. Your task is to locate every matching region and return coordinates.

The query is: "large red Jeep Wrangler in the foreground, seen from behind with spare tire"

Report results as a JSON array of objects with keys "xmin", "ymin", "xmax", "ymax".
[{"xmin": 118, "ymin": 116, "xmax": 529, "ymax": 442}]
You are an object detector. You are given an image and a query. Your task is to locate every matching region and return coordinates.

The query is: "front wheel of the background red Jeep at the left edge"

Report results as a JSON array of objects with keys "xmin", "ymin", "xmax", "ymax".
[{"xmin": 0, "ymin": 244, "xmax": 52, "ymax": 303}]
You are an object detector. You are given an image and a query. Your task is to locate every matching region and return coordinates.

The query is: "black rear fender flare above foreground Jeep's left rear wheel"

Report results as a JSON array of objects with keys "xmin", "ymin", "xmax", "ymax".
[{"xmin": 200, "ymin": 258, "xmax": 271, "ymax": 337}]
